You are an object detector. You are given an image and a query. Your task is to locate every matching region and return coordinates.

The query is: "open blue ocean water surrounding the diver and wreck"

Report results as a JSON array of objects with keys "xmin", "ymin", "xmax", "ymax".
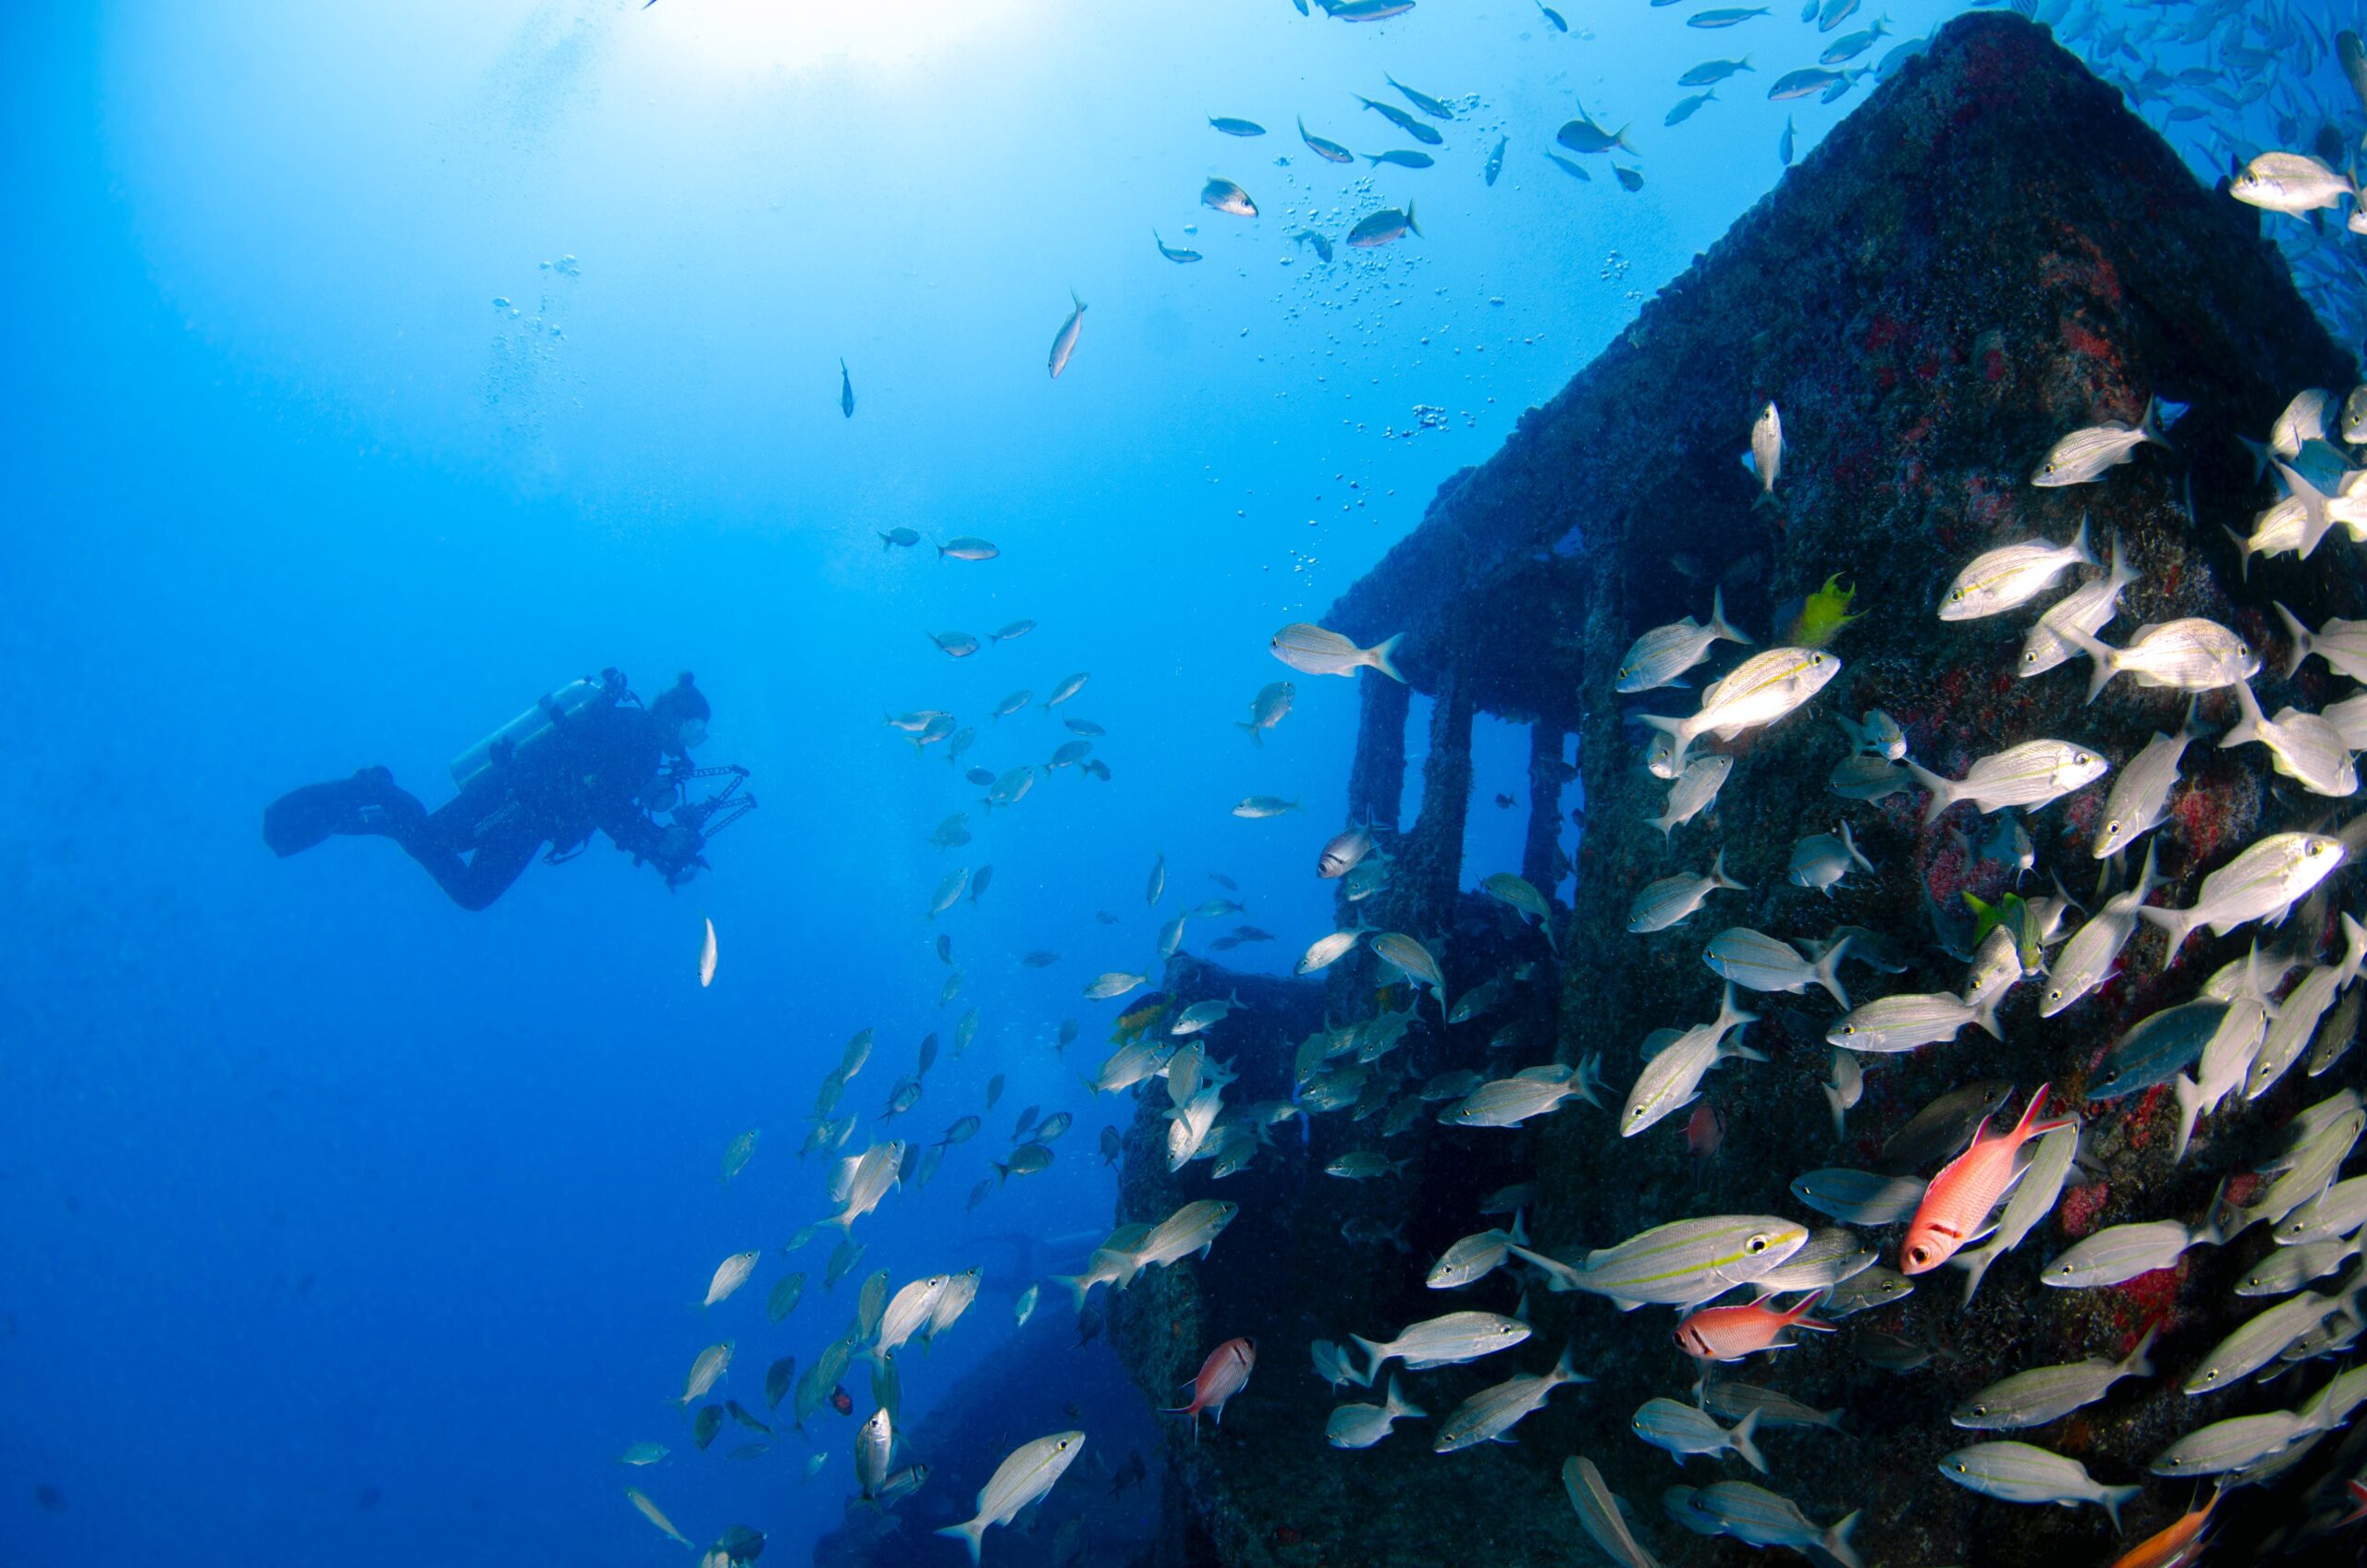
[{"xmin": 0, "ymin": 0, "xmax": 2332, "ymax": 1565}]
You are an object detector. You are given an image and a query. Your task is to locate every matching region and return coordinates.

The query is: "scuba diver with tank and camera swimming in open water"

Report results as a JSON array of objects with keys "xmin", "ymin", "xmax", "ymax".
[{"xmin": 263, "ymin": 670, "xmax": 755, "ymax": 910}]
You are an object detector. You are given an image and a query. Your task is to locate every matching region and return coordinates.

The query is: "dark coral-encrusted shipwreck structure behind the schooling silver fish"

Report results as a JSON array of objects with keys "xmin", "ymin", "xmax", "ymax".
[{"xmin": 1112, "ymin": 14, "xmax": 2367, "ymax": 1568}]
